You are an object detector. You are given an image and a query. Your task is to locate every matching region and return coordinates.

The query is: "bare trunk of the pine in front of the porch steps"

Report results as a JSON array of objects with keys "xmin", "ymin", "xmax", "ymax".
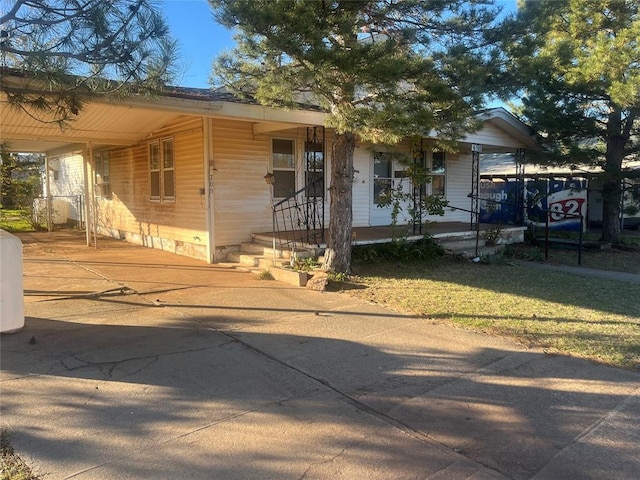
[{"xmin": 322, "ymin": 132, "xmax": 356, "ymax": 273}]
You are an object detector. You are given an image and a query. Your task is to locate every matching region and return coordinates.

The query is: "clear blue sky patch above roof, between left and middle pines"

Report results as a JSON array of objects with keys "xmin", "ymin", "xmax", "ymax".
[{"xmin": 160, "ymin": 0, "xmax": 516, "ymax": 88}]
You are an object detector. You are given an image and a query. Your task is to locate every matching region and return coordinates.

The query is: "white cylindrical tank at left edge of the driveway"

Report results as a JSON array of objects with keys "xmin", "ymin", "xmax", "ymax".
[{"xmin": 0, "ymin": 230, "xmax": 24, "ymax": 333}]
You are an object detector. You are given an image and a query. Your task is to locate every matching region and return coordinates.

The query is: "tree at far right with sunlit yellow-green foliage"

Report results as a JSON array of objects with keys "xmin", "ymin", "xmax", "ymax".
[{"xmin": 505, "ymin": 0, "xmax": 640, "ymax": 242}]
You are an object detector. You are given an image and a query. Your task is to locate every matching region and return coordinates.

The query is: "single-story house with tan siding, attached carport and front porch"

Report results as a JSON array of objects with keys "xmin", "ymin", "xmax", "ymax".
[{"xmin": 0, "ymin": 78, "xmax": 535, "ymax": 262}]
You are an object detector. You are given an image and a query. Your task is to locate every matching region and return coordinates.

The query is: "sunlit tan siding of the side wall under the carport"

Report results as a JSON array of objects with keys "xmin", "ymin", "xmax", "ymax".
[{"xmin": 97, "ymin": 117, "xmax": 207, "ymax": 258}]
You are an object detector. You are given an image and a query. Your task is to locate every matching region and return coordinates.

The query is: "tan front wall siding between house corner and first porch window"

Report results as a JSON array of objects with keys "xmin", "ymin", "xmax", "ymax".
[{"xmin": 212, "ymin": 119, "xmax": 272, "ymax": 247}]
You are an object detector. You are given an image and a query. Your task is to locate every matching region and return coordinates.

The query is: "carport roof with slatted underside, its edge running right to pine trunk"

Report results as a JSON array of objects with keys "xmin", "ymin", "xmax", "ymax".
[{"xmin": 0, "ymin": 76, "xmax": 324, "ymax": 155}]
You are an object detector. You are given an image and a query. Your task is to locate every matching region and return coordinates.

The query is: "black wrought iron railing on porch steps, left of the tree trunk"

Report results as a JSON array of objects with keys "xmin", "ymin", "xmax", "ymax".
[{"xmin": 273, "ymin": 179, "xmax": 324, "ymax": 250}]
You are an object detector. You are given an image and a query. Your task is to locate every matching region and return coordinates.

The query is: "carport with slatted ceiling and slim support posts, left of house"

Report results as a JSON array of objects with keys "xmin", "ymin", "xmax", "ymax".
[{"xmin": 0, "ymin": 75, "xmax": 215, "ymax": 249}]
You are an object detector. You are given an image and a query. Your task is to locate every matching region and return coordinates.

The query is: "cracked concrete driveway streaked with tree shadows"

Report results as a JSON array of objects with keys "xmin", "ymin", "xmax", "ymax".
[{"xmin": 1, "ymin": 232, "xmax": 640, "ymax": 480}]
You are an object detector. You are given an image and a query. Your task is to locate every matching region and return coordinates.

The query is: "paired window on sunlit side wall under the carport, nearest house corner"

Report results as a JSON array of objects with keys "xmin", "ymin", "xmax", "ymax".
[{"xmin": 149, "ymin": 138, "xmax": 176, "ymax": 202}]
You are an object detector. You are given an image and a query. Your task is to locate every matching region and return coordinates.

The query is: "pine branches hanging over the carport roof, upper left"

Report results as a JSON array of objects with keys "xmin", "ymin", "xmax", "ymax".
[{"xmin": 0, "ymin": 0, "xmax": 176, "ymax": 126}]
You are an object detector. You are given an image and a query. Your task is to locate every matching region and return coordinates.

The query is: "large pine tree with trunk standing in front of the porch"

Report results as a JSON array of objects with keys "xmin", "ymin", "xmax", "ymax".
[{"xmin": 210, "ymin": 0, "xmax": 504, "ymax": 272}]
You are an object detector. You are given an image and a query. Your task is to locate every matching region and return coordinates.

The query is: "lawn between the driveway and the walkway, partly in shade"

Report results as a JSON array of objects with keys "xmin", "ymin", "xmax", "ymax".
[{"xmin": 348, "ymin": 258, "xmax": 640, "ymax": 369}]
